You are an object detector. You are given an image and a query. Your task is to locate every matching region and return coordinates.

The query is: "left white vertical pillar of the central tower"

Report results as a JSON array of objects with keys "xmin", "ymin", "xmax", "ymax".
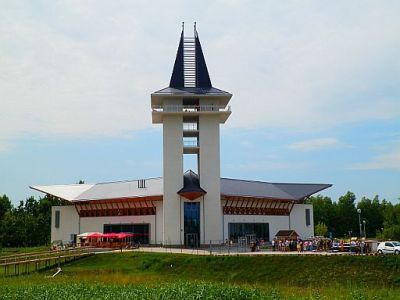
[{"xmin": 163, "ymin": 99, "xmax": 183, "ymax": 245}]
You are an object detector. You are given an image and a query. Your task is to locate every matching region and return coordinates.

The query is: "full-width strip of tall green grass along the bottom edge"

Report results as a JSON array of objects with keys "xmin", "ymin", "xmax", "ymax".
[{"xmin": 0, "ymin": 282, "xmax": 399, "ymax": 300}]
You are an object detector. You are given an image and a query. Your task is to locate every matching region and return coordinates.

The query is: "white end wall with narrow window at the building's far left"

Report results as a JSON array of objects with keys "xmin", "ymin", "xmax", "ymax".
[{"xmin": 51, "ymin": 205, "xmax": 79, "ymax": 242}]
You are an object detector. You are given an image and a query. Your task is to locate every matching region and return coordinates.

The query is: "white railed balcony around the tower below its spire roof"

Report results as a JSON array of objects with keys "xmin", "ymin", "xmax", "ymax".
[{"xmin": 152, "ymin": 104, "xmax": 232, "ymax": 124}]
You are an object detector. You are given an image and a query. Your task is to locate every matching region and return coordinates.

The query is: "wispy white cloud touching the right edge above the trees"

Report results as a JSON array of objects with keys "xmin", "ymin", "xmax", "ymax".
[{"xmin": 351, "ymin": 146, "xmax": 400, "ymax": 170}]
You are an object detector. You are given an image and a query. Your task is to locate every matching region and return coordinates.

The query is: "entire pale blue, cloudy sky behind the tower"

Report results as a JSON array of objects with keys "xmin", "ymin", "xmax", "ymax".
[{"xmin": 0, "ymin": 0, "xmax": 400, "ymax": 203}]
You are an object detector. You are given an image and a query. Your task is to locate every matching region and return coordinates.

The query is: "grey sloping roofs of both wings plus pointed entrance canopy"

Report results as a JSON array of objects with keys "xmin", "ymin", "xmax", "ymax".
[{"xmin": 30, "ymin": 170, "xmax": 332, "ymax": 201}]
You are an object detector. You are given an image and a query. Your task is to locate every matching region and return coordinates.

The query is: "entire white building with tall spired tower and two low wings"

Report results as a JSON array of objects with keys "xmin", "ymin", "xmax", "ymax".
[{"xmin": 31, "ymin": 26, "xmax": 331, "ymax": 246}]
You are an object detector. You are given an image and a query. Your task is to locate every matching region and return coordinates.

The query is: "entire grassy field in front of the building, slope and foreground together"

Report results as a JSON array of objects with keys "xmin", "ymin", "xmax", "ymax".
[{"xmin": 0, "ymin": 252, "xmax": 400, "ymax": 299}]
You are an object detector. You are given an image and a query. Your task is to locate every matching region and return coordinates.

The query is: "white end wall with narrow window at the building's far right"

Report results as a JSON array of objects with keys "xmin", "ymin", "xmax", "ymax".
[{"xmin": 290, "ymin": 204, "xmax": 314, "ymax": 239}]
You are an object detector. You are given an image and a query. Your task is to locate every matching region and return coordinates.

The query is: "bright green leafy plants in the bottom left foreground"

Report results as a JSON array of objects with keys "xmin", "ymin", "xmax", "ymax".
[{"xmin": 0, "ymin": 282, "xmax": 266, "ymax": 300}]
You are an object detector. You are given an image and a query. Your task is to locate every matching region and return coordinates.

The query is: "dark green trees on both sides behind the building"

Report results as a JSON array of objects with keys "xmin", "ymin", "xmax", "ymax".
[{"xmin": 0, "ymin": 192, "xmax": 400, "ymax": 247}]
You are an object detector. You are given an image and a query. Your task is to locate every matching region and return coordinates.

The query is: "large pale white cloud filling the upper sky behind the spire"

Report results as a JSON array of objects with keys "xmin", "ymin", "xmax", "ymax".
[{"xmin": 0, "ymin": 1, "xmax": 400, "ymax": 148}]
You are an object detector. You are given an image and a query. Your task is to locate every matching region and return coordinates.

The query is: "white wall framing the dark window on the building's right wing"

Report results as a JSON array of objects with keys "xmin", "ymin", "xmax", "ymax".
[{"xmin": 224, "ymin": 215, "xmax": 289, "ymax": 240}]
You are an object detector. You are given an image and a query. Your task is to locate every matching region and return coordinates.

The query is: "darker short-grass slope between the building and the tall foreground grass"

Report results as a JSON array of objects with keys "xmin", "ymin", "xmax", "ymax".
[{"xmin": 64, "ymin": 252, "xmax": 400, "ymax": 287}]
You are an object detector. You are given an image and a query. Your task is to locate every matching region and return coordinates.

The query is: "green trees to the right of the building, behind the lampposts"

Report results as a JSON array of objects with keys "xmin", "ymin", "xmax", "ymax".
[{"xmin": 307, "ymin": 192, "xmax": 400, "ymax": 240}]
